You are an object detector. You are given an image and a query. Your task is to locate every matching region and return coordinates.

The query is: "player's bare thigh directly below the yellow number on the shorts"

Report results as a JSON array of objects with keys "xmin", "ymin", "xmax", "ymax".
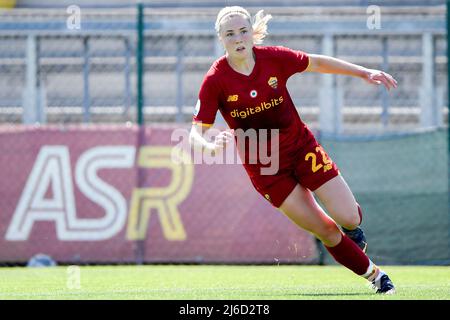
[{"xmin": 314, "ymin": 175, "xmax": 361, "ymax": 229}]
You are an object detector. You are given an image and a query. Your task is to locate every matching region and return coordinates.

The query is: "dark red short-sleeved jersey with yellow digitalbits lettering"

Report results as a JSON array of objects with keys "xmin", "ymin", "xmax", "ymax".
[{"xmin": 193, "ymin": 46, "xmax": 314, "ymax": 176}]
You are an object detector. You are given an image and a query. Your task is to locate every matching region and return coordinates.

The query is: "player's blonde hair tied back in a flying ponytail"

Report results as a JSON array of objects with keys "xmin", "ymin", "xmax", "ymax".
[{"xmin": 215, "ymin": 6, "xmax": 272, "ymax": 44}]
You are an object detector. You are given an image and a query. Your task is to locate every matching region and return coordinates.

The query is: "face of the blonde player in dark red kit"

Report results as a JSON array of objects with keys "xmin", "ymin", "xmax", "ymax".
[{"xmin": 219, "ymin": 15, "xmax": 253, "ymax": 59}]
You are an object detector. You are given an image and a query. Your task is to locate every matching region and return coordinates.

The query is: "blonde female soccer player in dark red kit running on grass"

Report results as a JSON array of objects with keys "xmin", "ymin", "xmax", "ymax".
[{"xmin": 190, "ymin": 6, "xmax": 397, "ymax": 294}]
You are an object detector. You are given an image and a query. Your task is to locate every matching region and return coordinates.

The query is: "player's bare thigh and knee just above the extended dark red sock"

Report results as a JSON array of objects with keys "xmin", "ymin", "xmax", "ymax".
[{"xmin": 279, "ymin": 184, "xmax": 341, "ymax": 247}]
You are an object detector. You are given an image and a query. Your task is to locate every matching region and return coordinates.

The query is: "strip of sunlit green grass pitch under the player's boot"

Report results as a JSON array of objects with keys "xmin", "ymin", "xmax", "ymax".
[{"xmin": 0, "ymin": 265, "xmax": 450, "ymax": 300}]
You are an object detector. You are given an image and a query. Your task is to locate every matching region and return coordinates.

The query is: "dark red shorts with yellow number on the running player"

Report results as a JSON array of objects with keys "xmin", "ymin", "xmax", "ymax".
[{"xmin": 250, "ymin": 139, "xmax": 339, "ymax": 208}]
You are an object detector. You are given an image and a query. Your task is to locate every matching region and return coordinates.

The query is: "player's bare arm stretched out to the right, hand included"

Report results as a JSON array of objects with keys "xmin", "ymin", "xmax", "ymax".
[{"xmin": 305, "ymin": 54, "xmax": 397, "ymax": 90}]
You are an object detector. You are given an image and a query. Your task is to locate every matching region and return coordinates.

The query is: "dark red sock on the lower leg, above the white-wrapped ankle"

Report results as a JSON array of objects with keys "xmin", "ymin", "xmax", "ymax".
[{"xmin": 325, "ymin": 234, "xmax": 370, "ymax": 276}]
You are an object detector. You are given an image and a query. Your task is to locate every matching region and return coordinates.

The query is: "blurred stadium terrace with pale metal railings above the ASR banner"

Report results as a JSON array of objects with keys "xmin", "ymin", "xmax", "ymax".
[{"xmin": 0, "ymin": 8, "xmax": 448, "ymax": 133}]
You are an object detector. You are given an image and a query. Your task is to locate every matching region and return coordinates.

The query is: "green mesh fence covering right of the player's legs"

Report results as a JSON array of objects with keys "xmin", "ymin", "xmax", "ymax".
[{"xmin": 321, "ymin": 129, "xmax": 450, "ymax": 264}]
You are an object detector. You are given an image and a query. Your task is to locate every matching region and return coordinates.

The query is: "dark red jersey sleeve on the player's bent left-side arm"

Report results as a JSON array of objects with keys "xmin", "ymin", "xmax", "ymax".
[{"xmin": 192, "ymin": 75, "xmax": 220, "ymax": 127}]
